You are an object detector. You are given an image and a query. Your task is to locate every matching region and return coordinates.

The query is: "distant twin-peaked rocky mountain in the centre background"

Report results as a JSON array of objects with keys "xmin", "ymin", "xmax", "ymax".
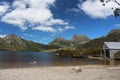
[{"xmin": 49, "ymin": 35, "xmax": 90, "ymax": 47}]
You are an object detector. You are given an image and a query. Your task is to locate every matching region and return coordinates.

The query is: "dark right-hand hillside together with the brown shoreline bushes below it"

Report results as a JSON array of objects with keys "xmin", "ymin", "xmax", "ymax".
[{"xmin": 53, "ymin": 29, "xmax": 120, "ymax": 57}]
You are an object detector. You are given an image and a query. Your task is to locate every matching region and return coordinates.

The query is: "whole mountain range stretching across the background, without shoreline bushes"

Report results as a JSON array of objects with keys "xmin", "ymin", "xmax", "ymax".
[{"xmin": 0, "ymin": 29, "xmax": 120, "ymax": 51}]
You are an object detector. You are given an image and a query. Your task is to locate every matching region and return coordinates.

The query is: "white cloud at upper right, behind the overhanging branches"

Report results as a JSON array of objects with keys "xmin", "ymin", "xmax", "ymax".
[{"xmin": 78, "ymin": 0, "xmax": 120, "ymax": 18}]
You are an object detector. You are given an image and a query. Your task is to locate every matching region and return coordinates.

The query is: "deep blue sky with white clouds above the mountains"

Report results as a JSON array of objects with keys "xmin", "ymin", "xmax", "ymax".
[{"xmin": 0, "ymin": 0, "xmax": 120, "ymax": 44}]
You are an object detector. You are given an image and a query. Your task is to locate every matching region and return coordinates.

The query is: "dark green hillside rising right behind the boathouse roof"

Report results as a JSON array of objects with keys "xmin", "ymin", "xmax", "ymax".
[{"xmin": 77, "ymin": 29, "xmax": 120, "ymax": 49}]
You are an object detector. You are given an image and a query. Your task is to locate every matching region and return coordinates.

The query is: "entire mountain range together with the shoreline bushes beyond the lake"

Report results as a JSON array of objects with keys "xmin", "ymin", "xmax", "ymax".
[{"xmin": 0, "ymin": 29, "xmax": 120, "ymax": 58}]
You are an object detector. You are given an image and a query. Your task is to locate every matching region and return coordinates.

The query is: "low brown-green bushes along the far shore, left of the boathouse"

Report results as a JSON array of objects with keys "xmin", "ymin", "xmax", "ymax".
[{"xmin": 54, "ymin": 48, "xmax": 100, "ymax": 58}]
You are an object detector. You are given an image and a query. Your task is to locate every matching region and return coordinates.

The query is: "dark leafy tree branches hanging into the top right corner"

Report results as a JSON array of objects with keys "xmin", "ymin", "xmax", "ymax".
[{"xmin": 100, "ymin": 0, "xmax": 120, "ymax": 17}]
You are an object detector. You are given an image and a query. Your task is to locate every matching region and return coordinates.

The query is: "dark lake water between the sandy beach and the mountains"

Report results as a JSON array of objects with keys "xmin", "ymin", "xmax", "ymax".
[{"xmin": 0, "ymin": 51, "xmax": 120, "ymax": 69}]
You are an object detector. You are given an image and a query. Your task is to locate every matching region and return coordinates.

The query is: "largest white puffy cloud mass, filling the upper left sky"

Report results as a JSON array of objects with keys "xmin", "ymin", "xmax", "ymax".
[{"xmin": 0, "ymin": 0, "xmax": 74, "ymax": 32}]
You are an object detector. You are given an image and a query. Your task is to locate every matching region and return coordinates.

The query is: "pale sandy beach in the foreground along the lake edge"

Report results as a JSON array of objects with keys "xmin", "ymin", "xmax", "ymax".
[{"xmin": 0, "ymin": 65, "xmax": 120, "ymax": 80}]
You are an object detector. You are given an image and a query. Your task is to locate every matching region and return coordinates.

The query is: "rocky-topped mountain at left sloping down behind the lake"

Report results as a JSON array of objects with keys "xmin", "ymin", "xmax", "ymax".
[{"xmin": 0, "ymin": 34, "xmax": 59, "ymax": 51}]
